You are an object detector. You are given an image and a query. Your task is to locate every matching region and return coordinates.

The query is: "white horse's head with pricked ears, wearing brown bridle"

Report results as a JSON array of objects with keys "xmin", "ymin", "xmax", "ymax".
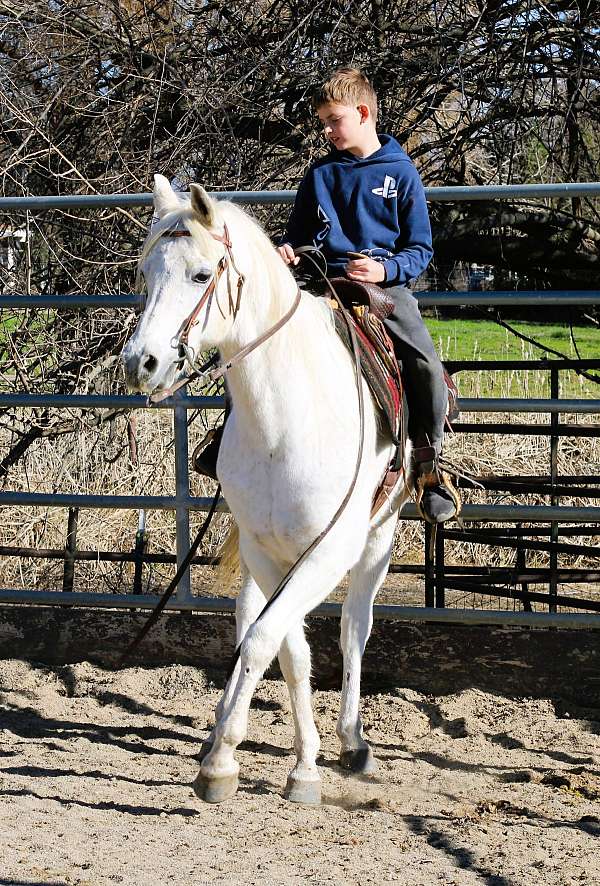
[{"xmin": 122, "ymin": 175, "xmax": 247, "ymax": 393}]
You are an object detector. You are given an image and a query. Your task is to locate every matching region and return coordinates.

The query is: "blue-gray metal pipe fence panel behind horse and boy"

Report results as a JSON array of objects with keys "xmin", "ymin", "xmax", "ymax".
[{"xmin": 0, "ymin": 182, "xmax": 600, "ymax": 627}]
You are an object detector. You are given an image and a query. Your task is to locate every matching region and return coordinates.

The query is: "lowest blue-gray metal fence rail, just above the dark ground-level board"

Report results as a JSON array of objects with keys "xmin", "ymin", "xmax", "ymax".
[{"xmin": 0, "ymin": 589, "xmax": 600, "ymax": 630}]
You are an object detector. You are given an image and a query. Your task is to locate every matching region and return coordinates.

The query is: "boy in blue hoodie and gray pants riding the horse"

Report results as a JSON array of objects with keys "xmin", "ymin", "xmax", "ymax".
[{"xmin": 196, "ymin": 68, "xmax": 458, "ymax": 523}]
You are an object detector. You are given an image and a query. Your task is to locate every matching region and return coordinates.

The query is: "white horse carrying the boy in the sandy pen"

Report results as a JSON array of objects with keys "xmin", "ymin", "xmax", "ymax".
[{"xmin": 123, "ymin": 175, "xmax": 407, "ymax": 803}]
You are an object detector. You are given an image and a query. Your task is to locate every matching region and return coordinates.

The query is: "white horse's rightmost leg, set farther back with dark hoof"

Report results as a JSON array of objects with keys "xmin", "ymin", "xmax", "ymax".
[{"xmin": 336, "ymin": 514, "xmax": 397, "ymax": 775}]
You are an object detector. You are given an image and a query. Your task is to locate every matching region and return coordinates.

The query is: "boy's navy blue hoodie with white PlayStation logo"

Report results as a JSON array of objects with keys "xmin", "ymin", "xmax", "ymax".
[{"xmin": 282, "ymin": 134, "xmax": 433, "ymax": 286}]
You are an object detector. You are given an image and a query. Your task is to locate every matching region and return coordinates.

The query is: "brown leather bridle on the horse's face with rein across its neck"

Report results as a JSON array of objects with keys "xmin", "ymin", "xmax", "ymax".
[{"xmin": 149, "ymin": 223, "xmax": 301, "ymax": 403}]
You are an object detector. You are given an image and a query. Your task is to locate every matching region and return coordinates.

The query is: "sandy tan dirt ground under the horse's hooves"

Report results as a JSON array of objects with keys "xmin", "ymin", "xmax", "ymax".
[{"xmin": 0, "ymin": 660, "xmax": 600, "ymax": 886}]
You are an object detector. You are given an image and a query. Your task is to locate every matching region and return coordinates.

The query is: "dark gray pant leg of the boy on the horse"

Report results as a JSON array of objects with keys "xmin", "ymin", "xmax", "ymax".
[{"xmin": 385, "ymin": 286, "xmax": 448, "ymax": 454}]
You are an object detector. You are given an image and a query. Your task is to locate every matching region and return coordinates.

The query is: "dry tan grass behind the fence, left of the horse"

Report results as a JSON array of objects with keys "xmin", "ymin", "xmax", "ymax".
[{"xmin": 0, "ymin": 396, "xmax": 228, "ymax": 593}]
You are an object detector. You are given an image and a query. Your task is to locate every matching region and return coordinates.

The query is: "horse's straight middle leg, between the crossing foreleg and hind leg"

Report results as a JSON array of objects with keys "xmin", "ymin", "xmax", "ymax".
[{"xmin": 279, "ymin": 623, "xmax": 321, "ymax": 804}]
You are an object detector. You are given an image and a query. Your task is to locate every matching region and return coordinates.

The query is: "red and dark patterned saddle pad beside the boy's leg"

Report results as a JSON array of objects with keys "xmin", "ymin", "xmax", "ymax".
[{"xmin": 333, "ymin": 305, "xmax": 402, "ymax": 445}]
